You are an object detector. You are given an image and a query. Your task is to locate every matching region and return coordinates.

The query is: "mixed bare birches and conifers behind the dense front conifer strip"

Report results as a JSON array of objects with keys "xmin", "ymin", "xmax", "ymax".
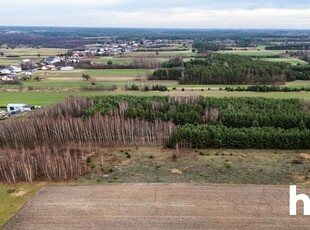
[{"xmin": 0, "ymin": 95, "xmax": 310, "ymax": 148}]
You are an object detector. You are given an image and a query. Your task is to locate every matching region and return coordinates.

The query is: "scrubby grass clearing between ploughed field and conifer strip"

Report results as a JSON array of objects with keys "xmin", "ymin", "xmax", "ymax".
[{"xmin": 77, "ymin": 147, "xmax": 310, "ymax": 185}]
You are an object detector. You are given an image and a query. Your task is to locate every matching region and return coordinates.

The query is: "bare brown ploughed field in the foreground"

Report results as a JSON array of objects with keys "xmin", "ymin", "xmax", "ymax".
[{"xmin": 4, "ymin": 184, "xmax": 310, "ymax": 230}]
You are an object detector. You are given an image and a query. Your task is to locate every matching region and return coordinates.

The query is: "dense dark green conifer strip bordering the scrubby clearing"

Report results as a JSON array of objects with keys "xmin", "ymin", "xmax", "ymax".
[{"xmin": 167, "ymin": 125, "xmax": 310, "ymax": 149}]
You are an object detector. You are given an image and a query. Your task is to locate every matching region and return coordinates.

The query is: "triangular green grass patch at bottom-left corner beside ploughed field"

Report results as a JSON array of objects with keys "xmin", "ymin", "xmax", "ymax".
[{"xmin": 0, "ymin": 183, "xmax": 45, "ymax": 228}]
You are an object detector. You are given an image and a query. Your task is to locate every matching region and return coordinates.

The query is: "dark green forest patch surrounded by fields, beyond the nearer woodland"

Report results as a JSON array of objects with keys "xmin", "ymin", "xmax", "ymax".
[{"xmin": 153, "ymin": 54, "xmax": 298, "ymax": 85}]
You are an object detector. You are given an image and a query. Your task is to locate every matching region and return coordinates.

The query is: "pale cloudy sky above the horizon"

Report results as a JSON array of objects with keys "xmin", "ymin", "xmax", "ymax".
[{"xmin": 0, "ymin": 0, "xmax": 310, "ymax": 29}]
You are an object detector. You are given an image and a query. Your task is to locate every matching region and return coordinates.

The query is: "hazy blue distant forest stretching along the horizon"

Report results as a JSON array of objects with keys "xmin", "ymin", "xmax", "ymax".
[{"xmin": 0, "ymin": 27, "xmax": 310, "ymax": 50}]
